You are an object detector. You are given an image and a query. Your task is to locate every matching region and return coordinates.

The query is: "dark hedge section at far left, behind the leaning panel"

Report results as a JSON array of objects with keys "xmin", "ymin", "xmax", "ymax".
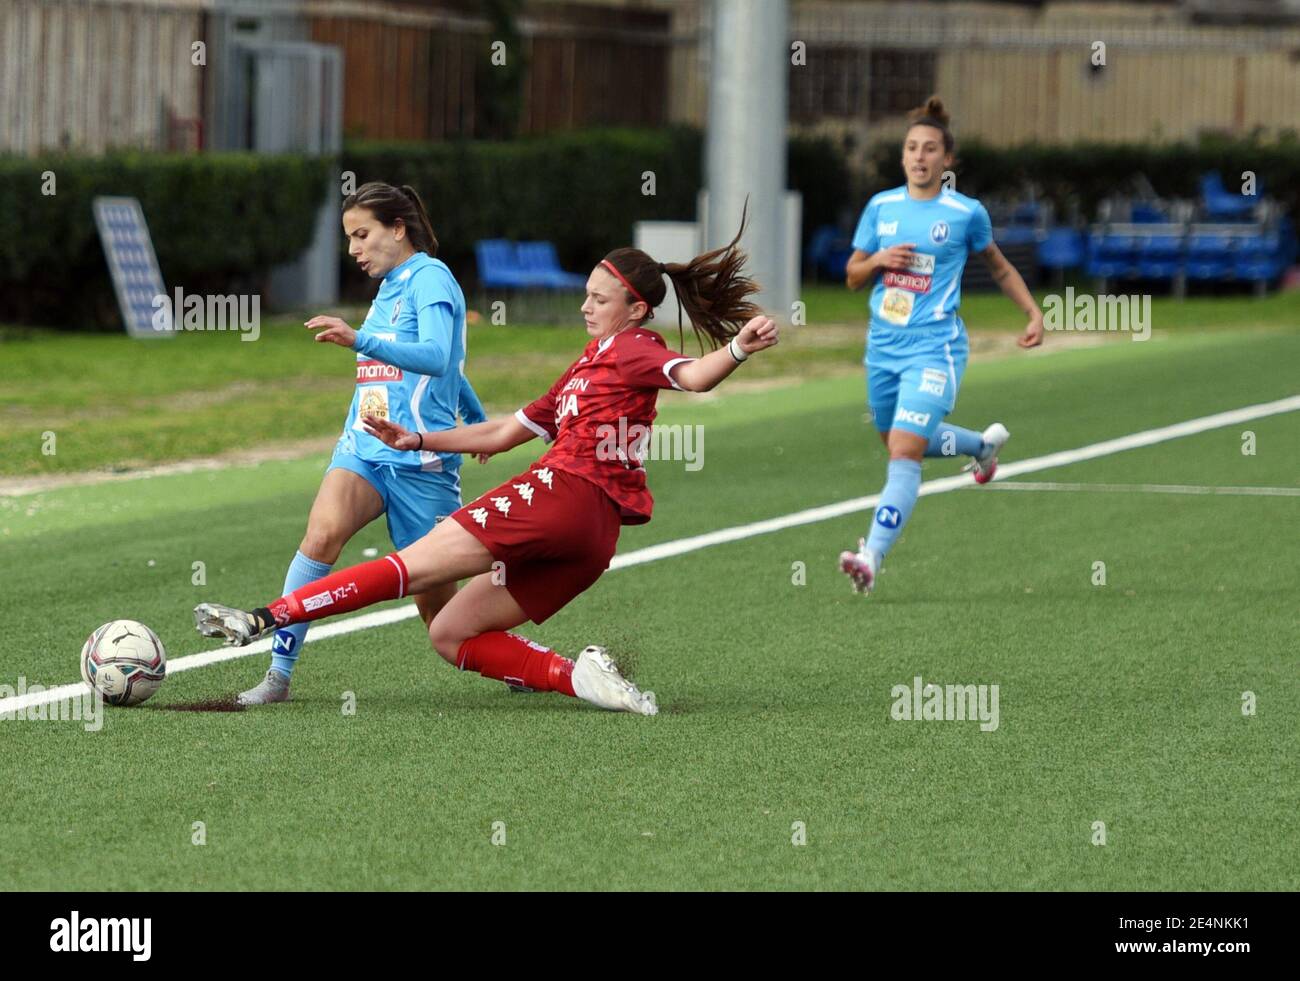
[{"xmin": 0, "ymin": 153, "xmax": 334, "ymax": 327}]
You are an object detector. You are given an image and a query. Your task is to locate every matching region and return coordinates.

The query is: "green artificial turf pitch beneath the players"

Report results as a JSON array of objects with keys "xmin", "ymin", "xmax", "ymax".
[{"xmin": 0, "ymin": 327, "xmax": 1300, "ymax": 890}]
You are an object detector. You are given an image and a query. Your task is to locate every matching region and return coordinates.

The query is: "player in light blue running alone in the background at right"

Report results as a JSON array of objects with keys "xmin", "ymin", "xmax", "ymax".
[{"xmin": 840, "ymin": 97, "xmax": 1043, "ymax": 592}]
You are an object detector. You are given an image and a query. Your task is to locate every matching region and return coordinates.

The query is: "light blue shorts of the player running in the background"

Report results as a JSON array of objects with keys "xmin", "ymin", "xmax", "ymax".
[{"xmin": 867, "ymin": 331, "xmax": 970, "ymax": 439}]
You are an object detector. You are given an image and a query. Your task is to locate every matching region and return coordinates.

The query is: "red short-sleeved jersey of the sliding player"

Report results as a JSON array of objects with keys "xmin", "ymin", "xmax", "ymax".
[{"xmin": 515, "ymin": 327, "xmax": 694, "ymax": 525}]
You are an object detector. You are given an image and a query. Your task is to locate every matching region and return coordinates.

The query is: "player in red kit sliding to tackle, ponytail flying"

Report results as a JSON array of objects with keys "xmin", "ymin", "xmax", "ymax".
[{"xmin": 194, "ymin": 224, "xmax": 777, "ymax": 715}]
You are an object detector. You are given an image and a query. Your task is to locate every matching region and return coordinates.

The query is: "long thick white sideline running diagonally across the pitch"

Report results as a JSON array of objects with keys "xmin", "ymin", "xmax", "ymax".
[{"xmin": 0, "ymin": 395, "xmax": 1300, "ymax": 712}]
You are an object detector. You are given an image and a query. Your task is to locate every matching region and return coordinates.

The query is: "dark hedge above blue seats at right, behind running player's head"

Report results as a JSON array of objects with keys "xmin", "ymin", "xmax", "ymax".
[{"xmin": 866, "ymin": 136, "xmax": 1300, "ymax": 222}]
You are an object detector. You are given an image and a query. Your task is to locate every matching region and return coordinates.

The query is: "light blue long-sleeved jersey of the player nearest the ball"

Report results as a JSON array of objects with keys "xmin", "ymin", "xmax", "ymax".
[{"xmin": 338, "ymin": 252, "xmax": 477, "ymax": 472}]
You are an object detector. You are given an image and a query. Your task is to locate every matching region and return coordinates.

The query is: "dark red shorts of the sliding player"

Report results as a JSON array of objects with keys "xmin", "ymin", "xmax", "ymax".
[{"xmin": 451, "ymin": 466, "xmax": 621, "ymax": 624}]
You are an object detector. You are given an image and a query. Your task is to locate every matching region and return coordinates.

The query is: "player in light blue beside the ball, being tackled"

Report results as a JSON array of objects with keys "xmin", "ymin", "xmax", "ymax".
[{"xmin": 238, "ymin": 183, "xmax": 488, "ymax": 706}]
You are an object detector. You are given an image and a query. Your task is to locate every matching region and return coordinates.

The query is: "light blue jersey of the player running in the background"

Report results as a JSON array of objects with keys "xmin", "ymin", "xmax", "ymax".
[{"xmin": 853, "ymin": 186, "xmax": 993, "ymax": 353}]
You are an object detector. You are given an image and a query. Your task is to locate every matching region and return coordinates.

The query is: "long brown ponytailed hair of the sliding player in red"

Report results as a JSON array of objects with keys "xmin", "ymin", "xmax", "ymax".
[{"xmin": 602, "ymin": 214, "xmax": 763, "ymax": 350}]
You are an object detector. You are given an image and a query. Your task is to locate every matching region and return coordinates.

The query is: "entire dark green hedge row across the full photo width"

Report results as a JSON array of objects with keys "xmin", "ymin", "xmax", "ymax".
[{"xmin": 10, "ymin": 127, "xmax": 1300, "ymax": 326}]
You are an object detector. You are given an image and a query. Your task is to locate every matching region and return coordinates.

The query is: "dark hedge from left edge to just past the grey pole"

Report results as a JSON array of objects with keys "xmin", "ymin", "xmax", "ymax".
[{"xmin": 0, "ymin": 127, "xmax": 849, "ymax": 326}]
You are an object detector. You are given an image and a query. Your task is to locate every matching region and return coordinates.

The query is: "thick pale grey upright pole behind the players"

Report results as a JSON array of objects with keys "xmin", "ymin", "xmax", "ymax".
[{"xmin": 705, "ymin": 0, "xmax": 794, "ymax": 320}]
